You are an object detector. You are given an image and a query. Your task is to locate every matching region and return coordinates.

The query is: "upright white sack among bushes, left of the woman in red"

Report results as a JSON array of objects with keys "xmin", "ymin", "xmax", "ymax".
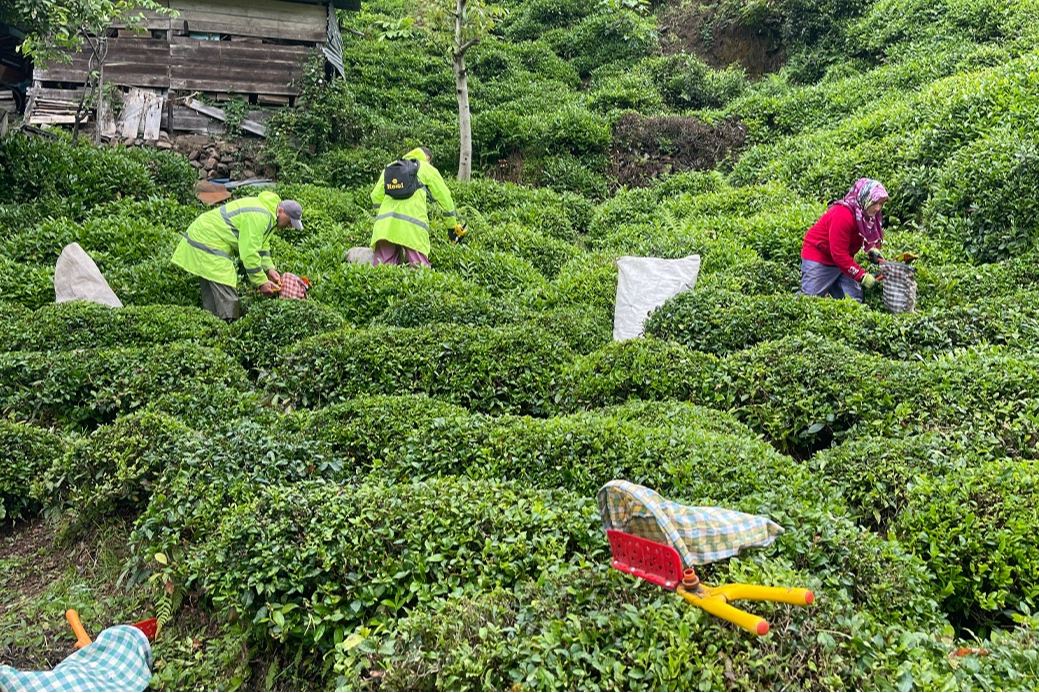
[{"xmin": 613, "ymin": 255, "xmax": 700, "ymax": 342}]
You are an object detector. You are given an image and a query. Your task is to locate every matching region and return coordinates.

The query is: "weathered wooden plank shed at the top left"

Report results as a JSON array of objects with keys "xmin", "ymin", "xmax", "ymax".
[{"xmin": 25, "ymin": 0, "xmax": 361, "ymax": 139}]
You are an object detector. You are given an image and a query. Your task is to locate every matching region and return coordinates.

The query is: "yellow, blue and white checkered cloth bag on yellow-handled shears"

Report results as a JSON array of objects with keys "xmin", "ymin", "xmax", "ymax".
[{"xmin": 598, "ymin": 480, "xmax": 783, "ymax": 568}]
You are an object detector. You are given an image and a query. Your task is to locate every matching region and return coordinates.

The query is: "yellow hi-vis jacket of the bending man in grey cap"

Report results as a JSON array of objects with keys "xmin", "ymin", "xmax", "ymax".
[{"xmin": 172, "ymin": 190, "xmax": 282, "ymax": 287}]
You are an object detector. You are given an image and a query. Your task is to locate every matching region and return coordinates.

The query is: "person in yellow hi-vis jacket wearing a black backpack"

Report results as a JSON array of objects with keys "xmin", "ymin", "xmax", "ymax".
[{"xmin": 372, "ymin": 146, "xmax": 465, "ymax": 267}]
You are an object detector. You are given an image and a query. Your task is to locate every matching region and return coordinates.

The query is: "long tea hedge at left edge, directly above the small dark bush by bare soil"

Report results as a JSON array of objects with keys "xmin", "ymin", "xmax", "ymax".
[{"xmin": 0, "ymin": 343, "xmax": 250, "ymax": 429}]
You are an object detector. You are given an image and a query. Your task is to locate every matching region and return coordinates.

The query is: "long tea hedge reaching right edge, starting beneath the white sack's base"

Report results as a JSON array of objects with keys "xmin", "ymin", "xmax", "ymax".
[{"xmin": 563, "ymin": 335, "xmax": 1039, "ymax": 450}]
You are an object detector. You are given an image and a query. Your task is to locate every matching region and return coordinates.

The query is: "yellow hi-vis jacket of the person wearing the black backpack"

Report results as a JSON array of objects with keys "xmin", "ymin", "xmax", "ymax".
[{"xmin": 371, "ymin": 149, "xmax": 455, "ymax": 256}]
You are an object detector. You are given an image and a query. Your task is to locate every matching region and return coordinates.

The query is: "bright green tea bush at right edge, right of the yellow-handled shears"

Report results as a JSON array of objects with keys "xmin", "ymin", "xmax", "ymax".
[{"xmin": 811, "ymin": 434, "xmax": 1039, "ymax": 628}]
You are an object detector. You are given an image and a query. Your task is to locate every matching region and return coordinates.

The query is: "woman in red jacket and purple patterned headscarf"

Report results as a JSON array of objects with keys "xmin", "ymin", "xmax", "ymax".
[{"xmin": 801, "ymin": 178, "xmax": 887, "ymax": 302}]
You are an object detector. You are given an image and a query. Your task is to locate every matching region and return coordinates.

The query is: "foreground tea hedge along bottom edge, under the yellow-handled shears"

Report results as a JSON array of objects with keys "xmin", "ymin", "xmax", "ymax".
[{"xmin": 335, "ymin": 561, "xmax": 1039, "ymax": 691}]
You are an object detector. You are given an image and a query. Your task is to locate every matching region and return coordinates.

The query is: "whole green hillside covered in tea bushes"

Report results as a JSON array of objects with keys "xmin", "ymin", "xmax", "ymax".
[{"xmin": 0, "ymin": 0, "xmax": 1039, "ymax": 691}]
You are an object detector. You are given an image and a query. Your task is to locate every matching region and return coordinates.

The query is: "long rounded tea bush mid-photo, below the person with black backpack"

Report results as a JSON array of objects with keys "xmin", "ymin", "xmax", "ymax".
[{"xmin": 268, "ymin": 325, "xmax": 572, "ymax": 414}]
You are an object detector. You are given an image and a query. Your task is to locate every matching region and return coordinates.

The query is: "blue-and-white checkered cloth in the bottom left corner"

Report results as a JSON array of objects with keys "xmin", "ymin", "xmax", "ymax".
[{"xmin": 0, "ymin": 625, "xmax": 152, "ymax": 693}]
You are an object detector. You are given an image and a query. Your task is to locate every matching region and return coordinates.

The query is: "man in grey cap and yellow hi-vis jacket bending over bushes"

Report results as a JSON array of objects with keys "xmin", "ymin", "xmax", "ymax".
[{"xmin": 172, "ymin": 190, "xmax": 303, "ymax": 322}]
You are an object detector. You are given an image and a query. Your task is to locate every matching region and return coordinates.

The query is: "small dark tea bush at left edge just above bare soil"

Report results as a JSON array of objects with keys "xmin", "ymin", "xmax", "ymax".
[{"xmin": 0, "ymin": 421, "xmax": 65, "ymax": 523}]
